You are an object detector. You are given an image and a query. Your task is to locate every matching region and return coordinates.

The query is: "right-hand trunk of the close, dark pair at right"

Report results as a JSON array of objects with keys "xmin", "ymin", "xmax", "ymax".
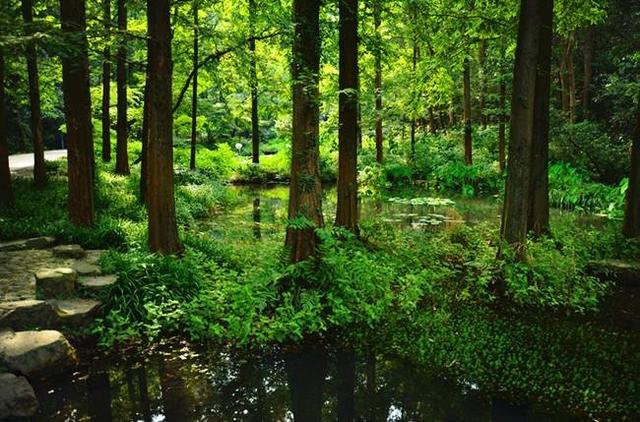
[{"xmin": 527, "ymin": 0, "xmax": 553, "ymax": 236}]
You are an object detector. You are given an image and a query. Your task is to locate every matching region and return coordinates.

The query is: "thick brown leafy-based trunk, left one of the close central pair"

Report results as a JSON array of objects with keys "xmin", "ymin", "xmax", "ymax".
[{"xmin": 286, "ymin": 0, "xmax": 324, "ymax": 263}]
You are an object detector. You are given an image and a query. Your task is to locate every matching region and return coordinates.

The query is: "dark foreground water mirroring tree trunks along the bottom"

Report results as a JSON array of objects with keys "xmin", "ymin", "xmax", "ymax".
[{"xmin": 34, "ymin": 344, "xmax": 569, "ymax": 422}]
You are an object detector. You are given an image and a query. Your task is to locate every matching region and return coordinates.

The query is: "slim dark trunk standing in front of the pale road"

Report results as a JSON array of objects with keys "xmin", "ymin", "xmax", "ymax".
[{"xmin": 22, "ymin": 0, "xmax": 47, "ymax": 187}]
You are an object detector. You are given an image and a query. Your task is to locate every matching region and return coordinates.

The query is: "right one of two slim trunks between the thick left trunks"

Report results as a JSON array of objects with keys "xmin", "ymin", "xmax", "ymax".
[{"xmin": 116, "ymin": 0, "xmax": 129, "ymax": 175}]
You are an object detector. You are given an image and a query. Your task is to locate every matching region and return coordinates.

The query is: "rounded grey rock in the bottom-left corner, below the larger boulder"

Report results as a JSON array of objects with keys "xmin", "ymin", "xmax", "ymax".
[{"xmin": 0, "ymin": 373, "xmax": 38, "ymax": 420}]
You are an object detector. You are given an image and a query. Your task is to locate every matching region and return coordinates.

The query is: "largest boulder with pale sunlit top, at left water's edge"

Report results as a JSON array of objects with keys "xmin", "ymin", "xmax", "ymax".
[{"xmin": 0, "ymin": 330, "xmax": 78, "ymax": 379}]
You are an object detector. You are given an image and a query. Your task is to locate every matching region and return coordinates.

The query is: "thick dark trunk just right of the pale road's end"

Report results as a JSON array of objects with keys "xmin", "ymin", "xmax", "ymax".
[{"xmin": 60, "ymin": 0, "xmax": 95, "ymax": 227}]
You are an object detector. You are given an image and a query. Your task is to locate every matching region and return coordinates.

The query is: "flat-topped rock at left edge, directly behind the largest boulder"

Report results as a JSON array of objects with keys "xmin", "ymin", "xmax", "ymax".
[{"xmin": 0, "ymin": 299, "xmax": 57, "ymax": 330}]
